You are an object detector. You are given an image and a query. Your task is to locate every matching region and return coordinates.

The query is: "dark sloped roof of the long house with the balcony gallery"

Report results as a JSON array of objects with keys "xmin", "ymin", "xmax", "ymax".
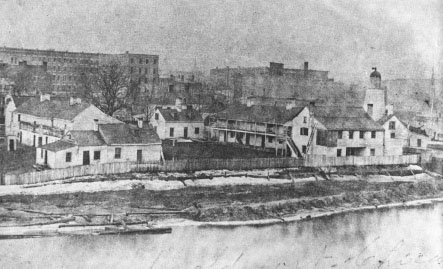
[{"xmin": 217, "ymin": 105, "xmax": 305, "ymax": 124}]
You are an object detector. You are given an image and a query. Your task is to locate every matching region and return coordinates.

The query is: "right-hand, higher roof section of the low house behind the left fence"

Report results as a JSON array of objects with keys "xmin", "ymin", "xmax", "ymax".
[{"xmin": 98, "ymin": 124, "xmax": 161, "ymax": 145}]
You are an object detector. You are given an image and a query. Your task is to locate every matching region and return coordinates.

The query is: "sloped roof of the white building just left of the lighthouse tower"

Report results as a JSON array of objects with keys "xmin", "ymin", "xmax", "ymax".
[{"xmin": 310, "ymin": 106, "xmax": 384, "ymax": 131}]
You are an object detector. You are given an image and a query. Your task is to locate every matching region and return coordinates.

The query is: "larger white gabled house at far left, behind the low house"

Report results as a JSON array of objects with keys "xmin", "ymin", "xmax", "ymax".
[{"xmin": 5, "ymin": 95, "xmax": 121, "ymax": 150}]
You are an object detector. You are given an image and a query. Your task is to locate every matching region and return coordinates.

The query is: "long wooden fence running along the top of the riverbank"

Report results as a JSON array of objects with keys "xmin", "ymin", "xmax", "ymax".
[{"xmin": 2, "ymin": 155, "xmax": 420, "ymax": 185}]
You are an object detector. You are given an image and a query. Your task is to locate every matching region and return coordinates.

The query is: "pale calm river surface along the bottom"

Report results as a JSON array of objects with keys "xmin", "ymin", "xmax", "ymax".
[{"xmin": 0, "ymin": 204, "xmax": 443, "ymax": 268}]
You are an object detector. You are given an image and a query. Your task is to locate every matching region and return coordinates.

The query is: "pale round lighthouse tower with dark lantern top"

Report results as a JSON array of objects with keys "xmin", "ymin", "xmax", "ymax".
[{"xmin": 363, "ymin": 67, "xmax": 387, "ymax": 121}]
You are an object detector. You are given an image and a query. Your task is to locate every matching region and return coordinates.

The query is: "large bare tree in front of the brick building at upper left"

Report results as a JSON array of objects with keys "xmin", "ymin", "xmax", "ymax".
[{"xmin": 79, "ymin": 60, "xmax": 141, "ymax": 116}]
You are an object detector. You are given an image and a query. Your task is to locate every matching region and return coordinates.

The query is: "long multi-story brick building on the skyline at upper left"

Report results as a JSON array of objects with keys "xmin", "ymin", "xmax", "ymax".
[{"xmin": 0, "ymin": 47, "xmax": 159, "ymax": 93}]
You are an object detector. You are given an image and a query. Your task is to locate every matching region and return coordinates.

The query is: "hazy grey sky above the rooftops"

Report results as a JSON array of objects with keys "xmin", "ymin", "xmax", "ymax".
[{"xmin": 0, "ymin": 0, "xmax": 443, "ymax": 82}]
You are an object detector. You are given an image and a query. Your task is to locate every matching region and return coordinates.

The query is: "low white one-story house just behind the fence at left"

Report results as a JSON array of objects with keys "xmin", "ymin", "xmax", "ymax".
[{"xmin": 36, "ymin": 123, "xmax": 163, "ymax": 168}]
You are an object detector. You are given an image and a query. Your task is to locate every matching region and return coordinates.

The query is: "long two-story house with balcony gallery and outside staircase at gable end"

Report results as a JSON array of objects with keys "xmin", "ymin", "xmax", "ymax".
[{"xmin": 207, "ymin": 105, "xmax": 312, "ymax": 157}]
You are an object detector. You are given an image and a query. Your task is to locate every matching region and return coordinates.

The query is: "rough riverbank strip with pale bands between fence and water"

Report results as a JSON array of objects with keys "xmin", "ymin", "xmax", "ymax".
[{"xmin": 0, "ymin": 163, "xmax": 443, "ymax": 233}]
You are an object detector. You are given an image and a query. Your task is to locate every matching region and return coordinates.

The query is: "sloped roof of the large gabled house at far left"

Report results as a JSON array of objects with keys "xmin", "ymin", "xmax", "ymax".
[{"xmin": 15, "ymin": 98, "xmax": 91, "ymax": 120}]
